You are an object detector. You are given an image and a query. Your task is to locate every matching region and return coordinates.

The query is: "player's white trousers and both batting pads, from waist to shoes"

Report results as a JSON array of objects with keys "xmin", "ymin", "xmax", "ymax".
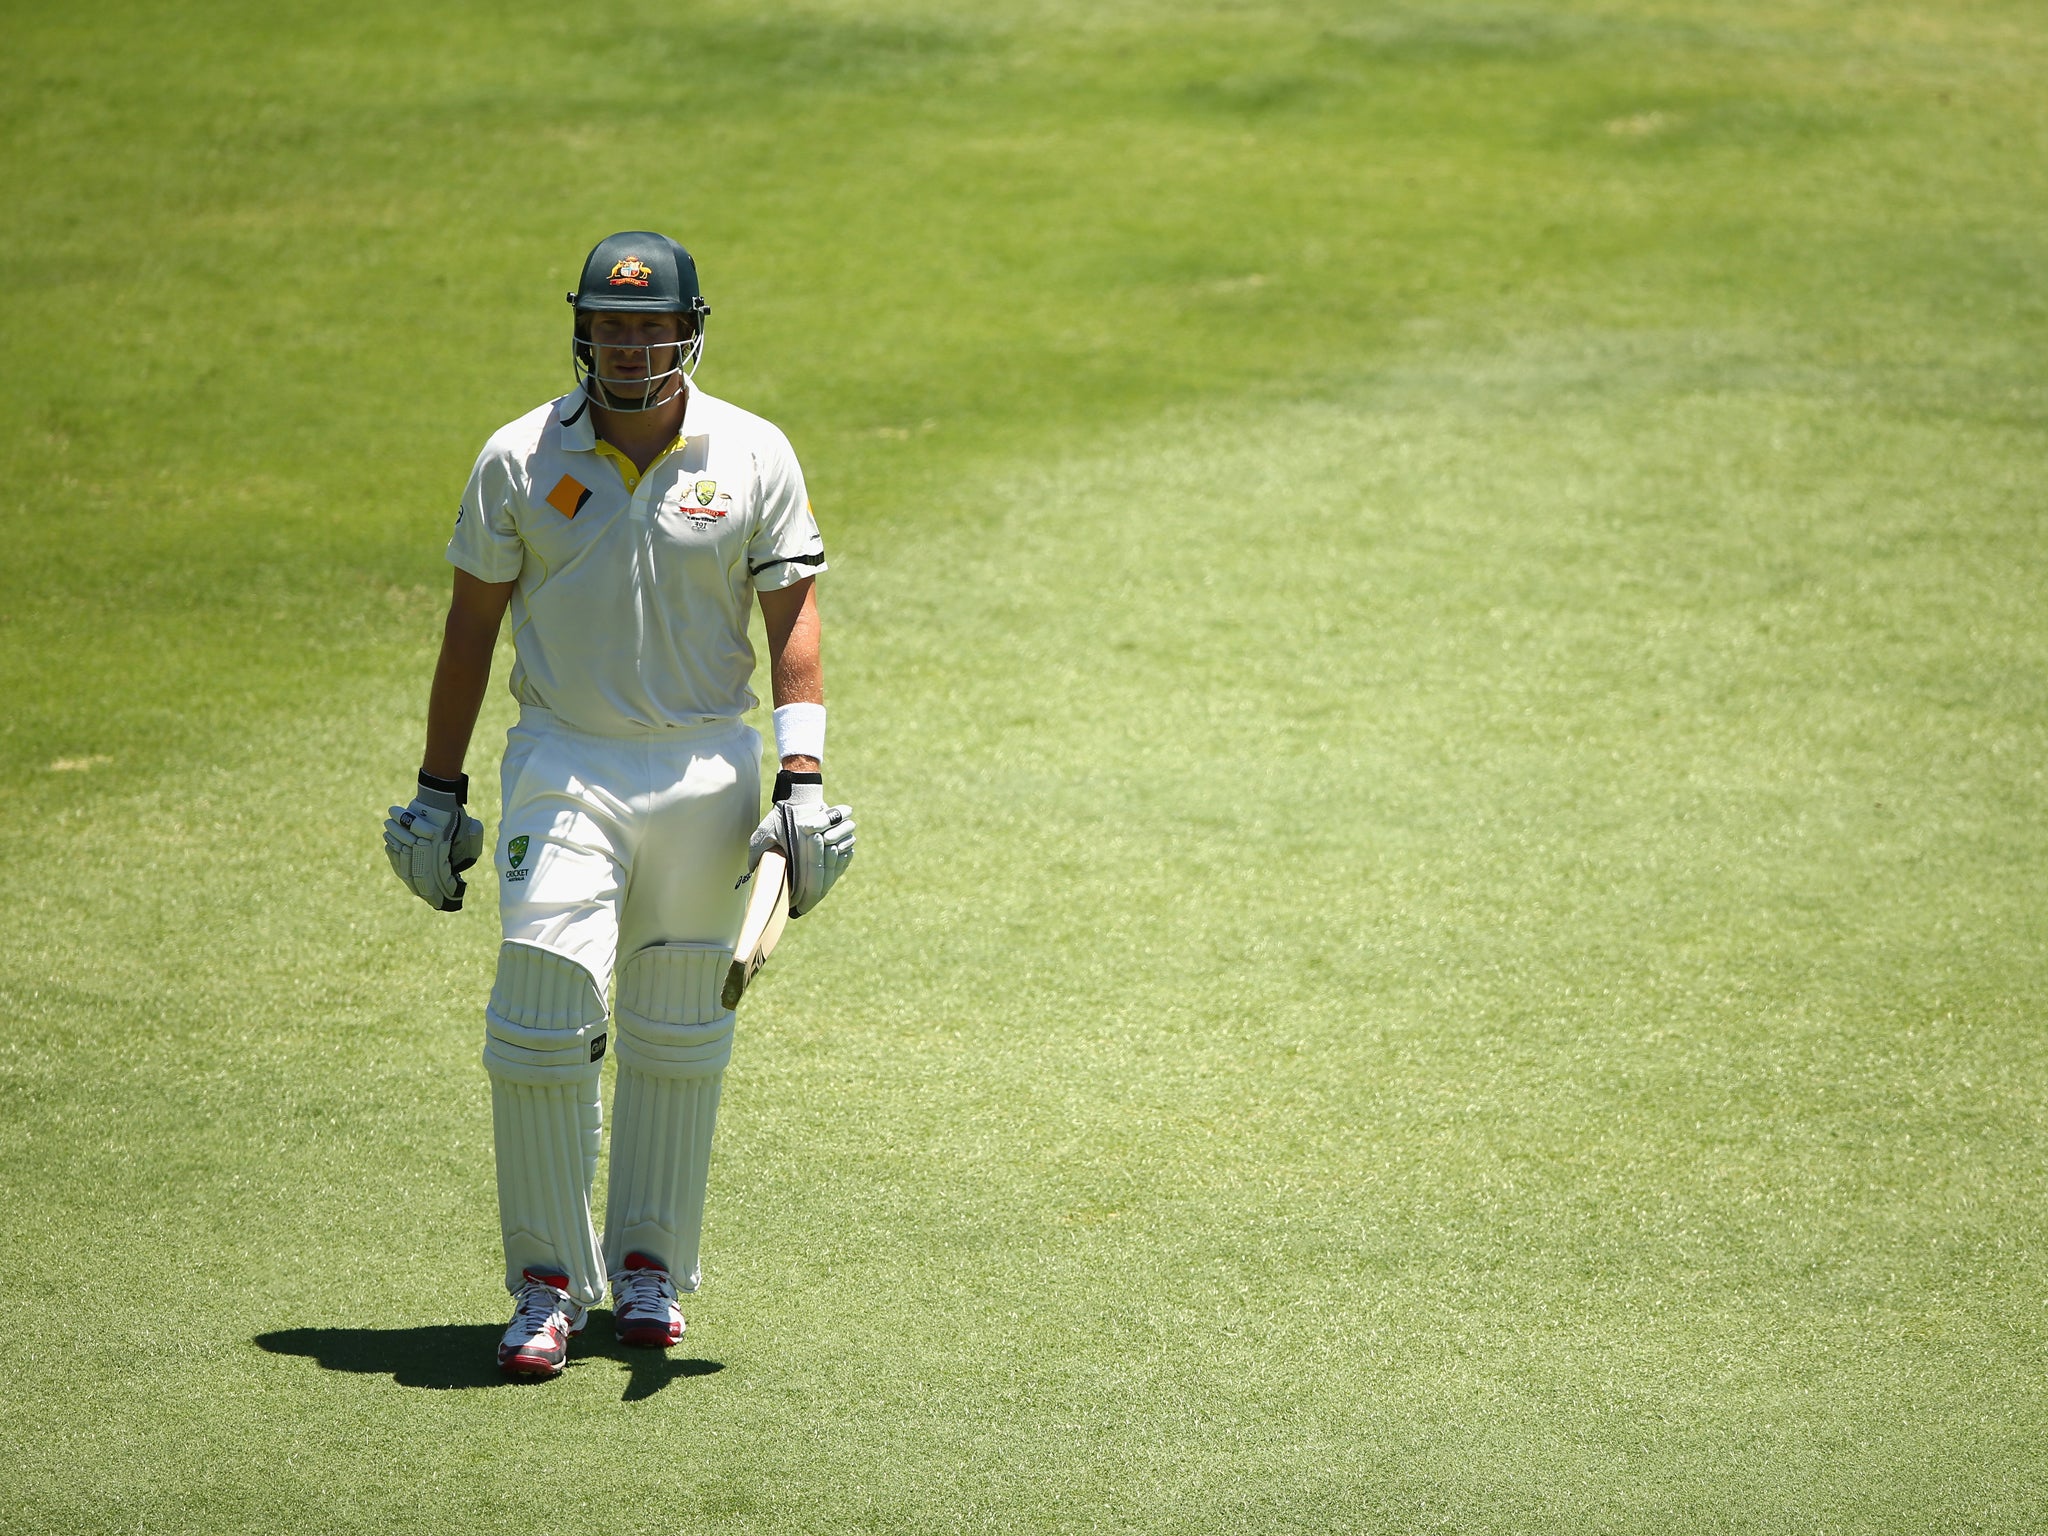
[{"xmin": 483, "ymin": 709, "xmax": 762, "ymax": 1307}]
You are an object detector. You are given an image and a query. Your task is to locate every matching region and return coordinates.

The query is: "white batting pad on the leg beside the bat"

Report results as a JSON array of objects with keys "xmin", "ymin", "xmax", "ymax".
[{"xmin": 604, "ymin": 944, "xmax": 733, "ymax": 1290}]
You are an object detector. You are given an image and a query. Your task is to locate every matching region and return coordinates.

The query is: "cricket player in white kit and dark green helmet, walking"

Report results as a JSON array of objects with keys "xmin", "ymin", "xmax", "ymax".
[{"xmin": 385, "ymin": 231, "xmax": 854, "ymax": 1378}]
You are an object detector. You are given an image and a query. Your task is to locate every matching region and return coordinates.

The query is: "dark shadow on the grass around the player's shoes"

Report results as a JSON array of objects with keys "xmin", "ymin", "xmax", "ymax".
[{"xmin": 256, "ymin": 1311, "xmax": 725, "ymax": 1403}]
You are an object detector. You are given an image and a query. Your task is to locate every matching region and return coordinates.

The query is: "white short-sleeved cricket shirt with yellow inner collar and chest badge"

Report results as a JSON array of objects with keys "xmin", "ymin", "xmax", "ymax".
[{"xmin": 449, "ymin": 387, "xmax": 825, "ymax": 735}]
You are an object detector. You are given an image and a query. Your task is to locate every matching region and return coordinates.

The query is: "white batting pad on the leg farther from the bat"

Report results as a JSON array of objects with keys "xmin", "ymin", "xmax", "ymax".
[{"xmin": 483, "ymin": 940, "xmax": 604, "ymax": 1307}]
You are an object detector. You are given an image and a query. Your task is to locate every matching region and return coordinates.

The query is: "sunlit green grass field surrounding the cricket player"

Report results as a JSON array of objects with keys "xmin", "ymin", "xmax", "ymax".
[{"xmin": 0, "ymin": 0, "xmax": 2048, "ymax": 1536}]
